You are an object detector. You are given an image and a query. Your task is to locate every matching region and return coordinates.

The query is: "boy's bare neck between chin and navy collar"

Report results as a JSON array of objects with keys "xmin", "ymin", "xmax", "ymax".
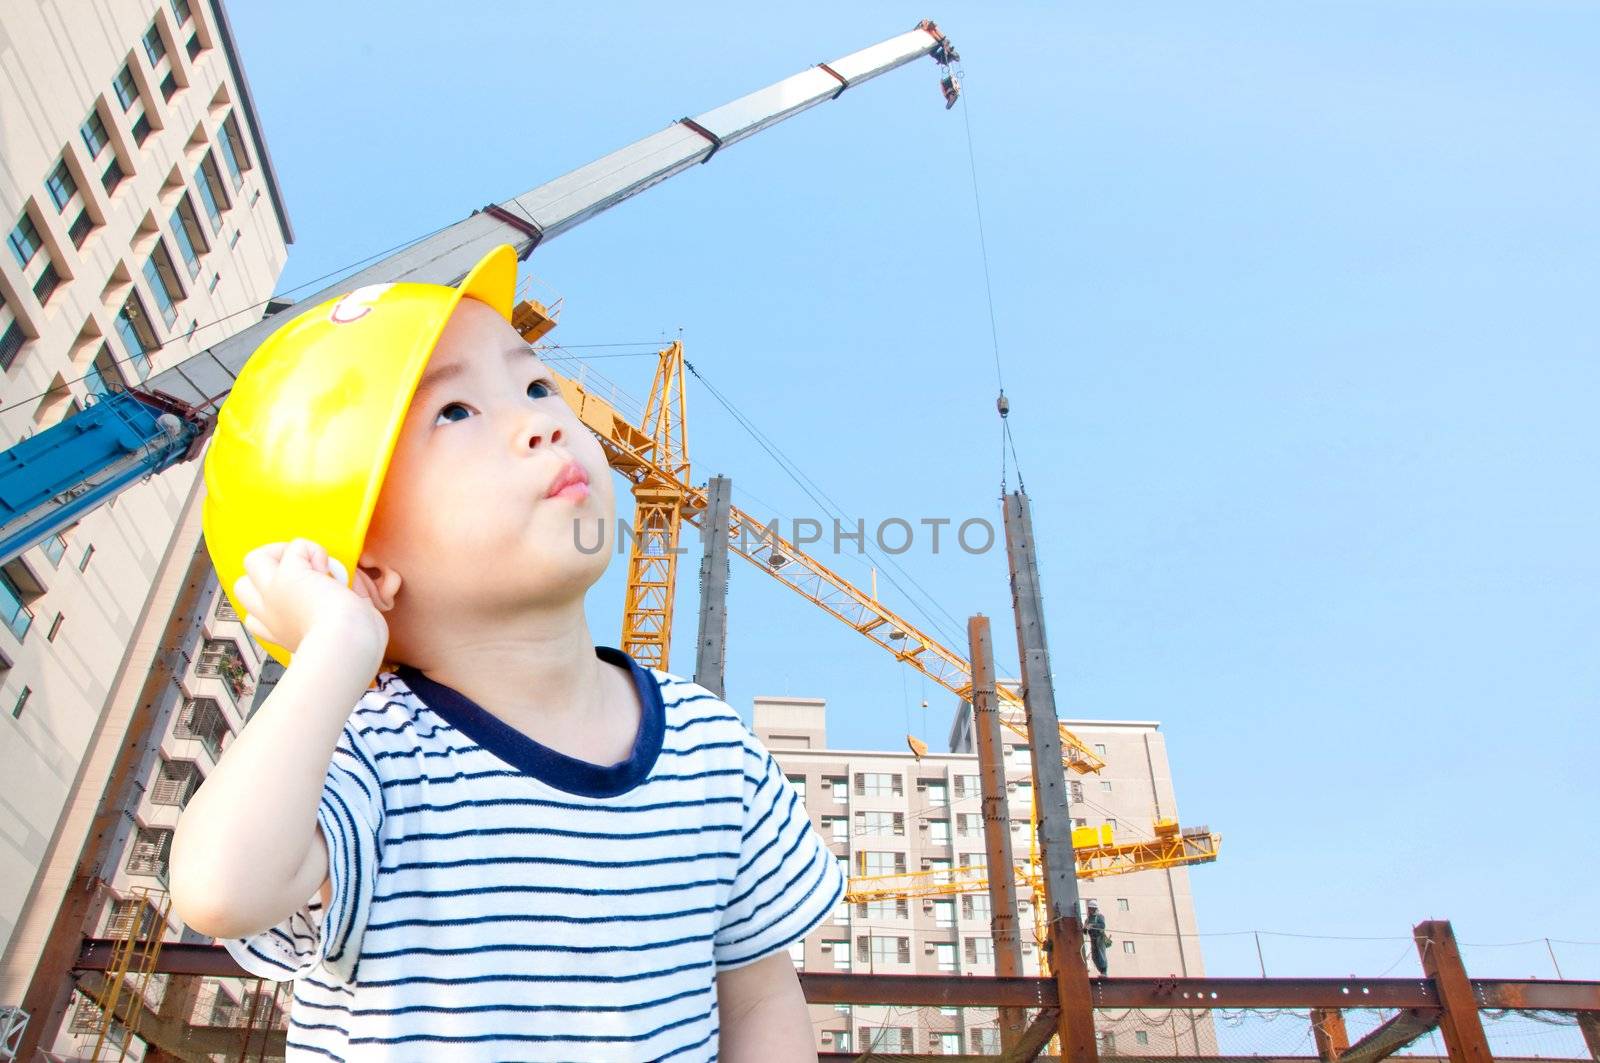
[{"xmin": 400, "ymin": 599, "xmax": 638, "ymax": 764}]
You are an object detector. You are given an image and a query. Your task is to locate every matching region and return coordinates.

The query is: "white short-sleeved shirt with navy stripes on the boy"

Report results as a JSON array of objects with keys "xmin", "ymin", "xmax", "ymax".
[{"xmin": 226, "ymin": 647, "xmax": 845, "ymax": 1061}]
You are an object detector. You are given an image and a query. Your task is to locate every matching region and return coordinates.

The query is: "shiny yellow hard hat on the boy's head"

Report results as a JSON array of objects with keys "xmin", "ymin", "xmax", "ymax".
[{"xmin": 202, "ymin": 245, "xmax": 517, "ymax": 663}]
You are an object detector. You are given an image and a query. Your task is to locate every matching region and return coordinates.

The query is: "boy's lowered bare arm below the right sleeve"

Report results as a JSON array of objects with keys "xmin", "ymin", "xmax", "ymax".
[{"xmin": 717, "ymin": 953, "xmax": 816, "ymax": 1063}]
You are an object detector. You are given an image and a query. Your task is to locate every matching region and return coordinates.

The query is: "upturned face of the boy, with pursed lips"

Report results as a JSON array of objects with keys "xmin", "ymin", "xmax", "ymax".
[{"xmin": 363, "ymin": 299, "xmax": 614, "ymax": 660}]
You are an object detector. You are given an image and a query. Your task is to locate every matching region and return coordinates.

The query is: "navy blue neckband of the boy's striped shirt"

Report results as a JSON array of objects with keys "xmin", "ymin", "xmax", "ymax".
[{"xmin": 398, "ymin": 645, "xmax": 666, "ymax": 797}]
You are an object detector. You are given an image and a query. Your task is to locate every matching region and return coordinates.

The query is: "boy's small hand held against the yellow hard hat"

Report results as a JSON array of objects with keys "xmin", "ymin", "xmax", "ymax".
[{"xmin": 234, "ymin": 540, "xmax": 389, "ymax": 668}]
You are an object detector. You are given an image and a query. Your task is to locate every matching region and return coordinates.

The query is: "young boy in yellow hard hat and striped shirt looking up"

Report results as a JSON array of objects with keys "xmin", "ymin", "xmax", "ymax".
[{"xmin": 171, "ymin": 247, "xmax": 843, "ymax": 1063}]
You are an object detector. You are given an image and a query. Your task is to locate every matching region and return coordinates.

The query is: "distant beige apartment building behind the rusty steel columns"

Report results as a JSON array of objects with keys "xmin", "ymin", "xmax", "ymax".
[{"xmin": 754, "ymin": 698, "xmax": 1216, "ymax": 1055}]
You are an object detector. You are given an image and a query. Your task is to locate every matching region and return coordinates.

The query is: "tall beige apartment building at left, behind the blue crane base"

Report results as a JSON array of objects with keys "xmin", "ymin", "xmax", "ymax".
[{"xmin": 0, "ymin": 0, "xmax": 293, "ymax": 1043}]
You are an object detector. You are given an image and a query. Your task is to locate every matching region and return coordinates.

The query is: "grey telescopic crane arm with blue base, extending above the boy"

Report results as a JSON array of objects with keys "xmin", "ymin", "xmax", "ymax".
[{"xmin": 0, "ymin": 21, "xmax": 958, "ymax": 564}]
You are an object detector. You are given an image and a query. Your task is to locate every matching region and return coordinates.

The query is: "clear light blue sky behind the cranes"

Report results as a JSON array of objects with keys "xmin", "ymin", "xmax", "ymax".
[{"xmin": 230, "ymin": 0, "xmax": 1600, "ymax": 978}]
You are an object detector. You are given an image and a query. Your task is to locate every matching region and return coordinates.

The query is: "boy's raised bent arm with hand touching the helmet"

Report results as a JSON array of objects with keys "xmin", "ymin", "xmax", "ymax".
[{"xmin": 171, "ymin": 543, "xmax": 386, "ymax": 938}]
